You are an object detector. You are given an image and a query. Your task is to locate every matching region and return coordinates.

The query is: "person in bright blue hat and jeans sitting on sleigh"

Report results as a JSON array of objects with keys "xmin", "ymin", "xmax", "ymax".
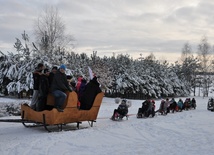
[{"xmin": 51, "ymin": 64, "xmax": 72, "ymax": 112}]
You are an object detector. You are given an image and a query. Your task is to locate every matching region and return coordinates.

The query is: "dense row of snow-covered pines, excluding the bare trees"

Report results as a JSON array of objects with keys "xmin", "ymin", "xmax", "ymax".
[{"xmin": 0, "ymin": 32, "xmax": 200, "ymax": 98}]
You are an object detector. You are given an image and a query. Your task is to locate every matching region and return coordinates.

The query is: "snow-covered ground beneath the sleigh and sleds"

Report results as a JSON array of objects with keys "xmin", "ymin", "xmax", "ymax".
[{"xmin": 0, "ymin": 97, "xmax": 214, "ymax": 155}]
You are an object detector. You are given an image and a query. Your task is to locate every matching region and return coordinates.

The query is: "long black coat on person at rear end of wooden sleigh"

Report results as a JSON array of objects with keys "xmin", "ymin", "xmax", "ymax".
[{"xmin": 80, "ymin": 77, "xmax": 101, "ymax": 110}]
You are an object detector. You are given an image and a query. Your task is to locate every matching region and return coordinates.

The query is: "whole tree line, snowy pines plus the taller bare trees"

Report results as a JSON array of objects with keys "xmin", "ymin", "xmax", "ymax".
[{"xmin": 0, "ymin": 7, "xmax": 214, "ymax": 99}]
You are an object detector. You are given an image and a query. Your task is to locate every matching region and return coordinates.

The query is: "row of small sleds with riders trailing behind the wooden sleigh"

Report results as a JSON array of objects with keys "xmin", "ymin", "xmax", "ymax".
[{"xmin": 111, "ymin": 98, "xmax": 196, "ymax": 121}]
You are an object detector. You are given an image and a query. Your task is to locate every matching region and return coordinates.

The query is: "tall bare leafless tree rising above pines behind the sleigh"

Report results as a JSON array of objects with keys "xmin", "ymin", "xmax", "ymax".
[{"xmin": 34, "ymin": 6, "xmax": 74, "ymax": 55}]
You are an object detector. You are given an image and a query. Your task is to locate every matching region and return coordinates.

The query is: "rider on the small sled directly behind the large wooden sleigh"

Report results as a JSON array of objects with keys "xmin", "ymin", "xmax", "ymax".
[{"xmin": 111, "ymin": 99, "xmax": 129, "ymax": 120}]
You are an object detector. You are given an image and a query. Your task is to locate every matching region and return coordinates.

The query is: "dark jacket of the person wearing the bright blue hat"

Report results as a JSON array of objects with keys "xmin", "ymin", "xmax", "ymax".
[{"xmin": 51, "ymin": 70, "xmax": 72, "ymax": 92}]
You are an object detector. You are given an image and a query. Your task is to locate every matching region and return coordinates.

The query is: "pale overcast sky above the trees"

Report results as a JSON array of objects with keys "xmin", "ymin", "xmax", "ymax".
[{"xmin": 0, "ymin": 0, "xmax": 214, "ymax": 60}]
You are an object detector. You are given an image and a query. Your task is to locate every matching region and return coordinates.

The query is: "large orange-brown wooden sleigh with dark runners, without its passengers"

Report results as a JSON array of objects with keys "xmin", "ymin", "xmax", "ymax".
[{"xmin": 0, "ymin": 91, "xmax": 104, "ymax": 132}]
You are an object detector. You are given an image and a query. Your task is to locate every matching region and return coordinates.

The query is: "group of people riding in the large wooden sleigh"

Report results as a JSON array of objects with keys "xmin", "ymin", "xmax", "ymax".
[{"xmin": 30, "ymin": 63, "xmax": 101, "ymax": 112}]
